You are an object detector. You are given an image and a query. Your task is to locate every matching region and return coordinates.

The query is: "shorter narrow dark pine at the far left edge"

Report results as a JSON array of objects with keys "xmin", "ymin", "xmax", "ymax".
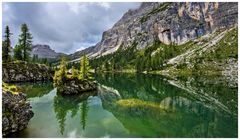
[{"xmin": 2, "ymin": 26, "xmax": 12, "ymax": 62}]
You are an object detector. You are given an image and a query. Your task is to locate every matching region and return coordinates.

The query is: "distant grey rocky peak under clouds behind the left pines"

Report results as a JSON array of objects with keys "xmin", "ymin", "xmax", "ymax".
[{"xmin": 31, "ymin": 44, "xmax": 65, "ymax": 58}]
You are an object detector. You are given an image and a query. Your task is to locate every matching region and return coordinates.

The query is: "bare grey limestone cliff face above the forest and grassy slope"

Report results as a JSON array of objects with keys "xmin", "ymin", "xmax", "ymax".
[{"xmin": 85, "ymin": 2, "xmax": 238, "ymax": 57}]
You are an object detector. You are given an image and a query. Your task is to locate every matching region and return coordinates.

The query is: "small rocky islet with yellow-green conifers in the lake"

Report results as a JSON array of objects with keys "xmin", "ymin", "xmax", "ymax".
[{"xmin": 53, "ymin": 55, "xmax": 97, "ymax": 95}]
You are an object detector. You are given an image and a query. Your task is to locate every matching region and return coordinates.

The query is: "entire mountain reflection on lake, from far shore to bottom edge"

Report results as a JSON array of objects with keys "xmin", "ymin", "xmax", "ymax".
[{"xmin": 94, "ymin": 74, "xmax": 237, "ymax": 137}]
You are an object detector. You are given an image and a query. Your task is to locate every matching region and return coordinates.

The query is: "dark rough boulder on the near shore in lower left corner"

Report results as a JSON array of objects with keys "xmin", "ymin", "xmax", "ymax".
[{"xmin": 2, "ymin": 90, "xmax": 34, "ymax": 136}]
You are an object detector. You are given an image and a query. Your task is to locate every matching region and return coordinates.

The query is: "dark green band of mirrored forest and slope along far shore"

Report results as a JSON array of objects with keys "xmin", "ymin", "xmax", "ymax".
[{"xmin": 96, "ymin": 74, "xmax": 238, "ymax": 115}]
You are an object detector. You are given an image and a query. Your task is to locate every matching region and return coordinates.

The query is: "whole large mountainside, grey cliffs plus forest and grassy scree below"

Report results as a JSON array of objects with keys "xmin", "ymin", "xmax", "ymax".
[{"xmin": 65, "ymin": 2, "xmax": 238, "ymax": 82}]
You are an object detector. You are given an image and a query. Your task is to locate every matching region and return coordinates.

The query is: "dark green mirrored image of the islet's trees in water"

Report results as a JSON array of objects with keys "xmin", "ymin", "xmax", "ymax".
[{"xmin": 54, "ymin": 92, "xmax": 96, "ymax": 135}]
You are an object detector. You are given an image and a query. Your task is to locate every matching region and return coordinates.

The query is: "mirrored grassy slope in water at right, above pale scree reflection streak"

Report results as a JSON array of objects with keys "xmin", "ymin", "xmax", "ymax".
[{"xmin": 173, "ymin": 76, "xmax": 238, "ymax": 115}]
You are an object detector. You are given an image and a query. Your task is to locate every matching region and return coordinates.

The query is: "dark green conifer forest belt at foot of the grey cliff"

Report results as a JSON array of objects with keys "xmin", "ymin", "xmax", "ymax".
[{"xmin": 90, "ymin": 39, "xmax": 180, "ymax": 72}]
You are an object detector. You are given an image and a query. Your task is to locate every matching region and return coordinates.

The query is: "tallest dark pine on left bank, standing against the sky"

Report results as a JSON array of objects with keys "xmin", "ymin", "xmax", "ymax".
[{"xmin": 18, "ymin": 23, "xmax": 32, "ymax": 61}]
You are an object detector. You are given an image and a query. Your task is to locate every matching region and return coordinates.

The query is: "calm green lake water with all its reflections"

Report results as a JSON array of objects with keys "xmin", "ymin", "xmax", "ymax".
[{"xmin": 6, "ymin": 74, "xmax": 238, "ymax": 138}]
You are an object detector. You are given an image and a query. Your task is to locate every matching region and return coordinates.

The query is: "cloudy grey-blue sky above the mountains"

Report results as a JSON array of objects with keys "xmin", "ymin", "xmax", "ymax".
[{"xmin": 2, "ymin": 3, "xmax": 140, "ymax": 54}]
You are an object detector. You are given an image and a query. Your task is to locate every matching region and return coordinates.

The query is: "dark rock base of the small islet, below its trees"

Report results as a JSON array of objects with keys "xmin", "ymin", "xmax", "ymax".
[{"xmin": 57, "ymin": 78, "xmax": 97, "ymax": 94}]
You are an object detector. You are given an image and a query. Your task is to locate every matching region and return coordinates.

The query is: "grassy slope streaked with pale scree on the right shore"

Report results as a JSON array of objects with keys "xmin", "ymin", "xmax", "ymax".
[{"xmin": 161, "ymin": 27, "xmax": 238, "ymax": 83}]
